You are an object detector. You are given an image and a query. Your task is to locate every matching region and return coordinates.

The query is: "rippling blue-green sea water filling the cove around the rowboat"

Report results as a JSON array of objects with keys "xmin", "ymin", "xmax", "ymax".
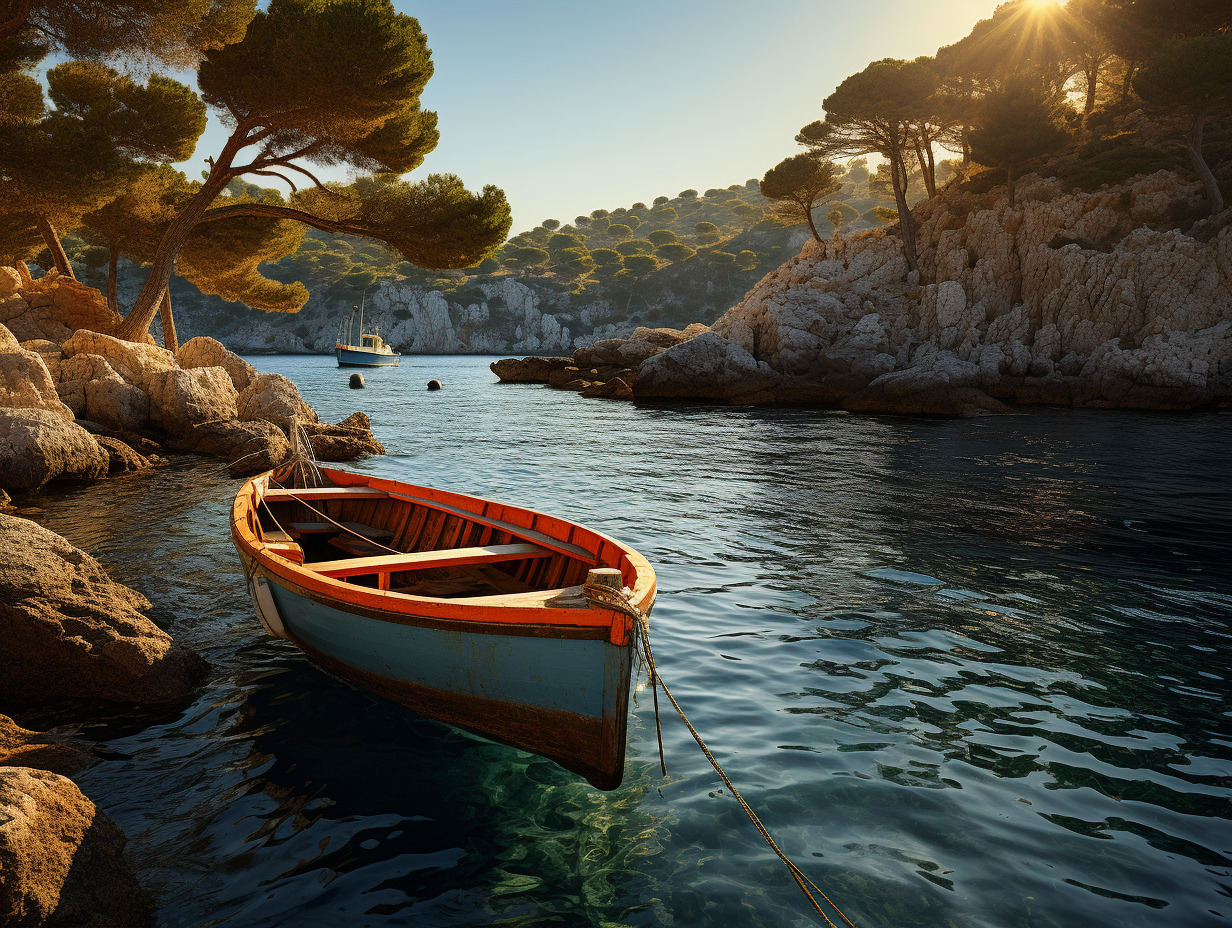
[{"xmin": 28, "ymin": 357, "xmax": 1232, "ymax": 928}]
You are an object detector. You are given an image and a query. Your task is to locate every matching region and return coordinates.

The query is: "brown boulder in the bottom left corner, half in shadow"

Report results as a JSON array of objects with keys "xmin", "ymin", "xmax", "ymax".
[{"xmin": 0, "ymin": 767, "xmax": 154, "ymax": 928}]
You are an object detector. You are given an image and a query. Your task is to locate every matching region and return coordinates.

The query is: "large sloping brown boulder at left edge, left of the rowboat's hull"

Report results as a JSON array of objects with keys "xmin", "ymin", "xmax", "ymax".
[{"xmin": 0, "ymin": 515, "xmax": 205, "ymax": 707}]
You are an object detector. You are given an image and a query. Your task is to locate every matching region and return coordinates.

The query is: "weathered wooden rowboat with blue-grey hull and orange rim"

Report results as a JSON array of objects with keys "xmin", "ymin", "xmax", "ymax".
[{"xmin": 232, "ymin": 468, "xmax": 655, "ymax": 789}]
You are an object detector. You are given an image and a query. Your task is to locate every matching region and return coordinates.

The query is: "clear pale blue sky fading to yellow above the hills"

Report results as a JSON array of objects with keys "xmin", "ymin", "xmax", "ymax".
[{"xmin": 184, "ymin": 0, "xmax": 998, "ymax": 232}]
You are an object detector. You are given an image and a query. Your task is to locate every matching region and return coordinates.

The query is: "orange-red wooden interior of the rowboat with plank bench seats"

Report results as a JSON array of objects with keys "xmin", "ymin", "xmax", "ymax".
[{"xmin": 257, "ymin": 478, "xmax": 611, "ymax": 599}]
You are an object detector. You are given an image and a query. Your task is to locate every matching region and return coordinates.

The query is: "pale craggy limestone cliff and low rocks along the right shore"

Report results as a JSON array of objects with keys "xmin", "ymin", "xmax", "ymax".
[{"xmin": 493, "ymin": 171, "xmax": 1232, "ymax": 415}]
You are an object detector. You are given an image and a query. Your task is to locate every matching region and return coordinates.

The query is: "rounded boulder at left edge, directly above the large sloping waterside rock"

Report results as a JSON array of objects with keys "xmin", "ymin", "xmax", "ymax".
[{"xmin": 0, "ymin": 409, "xmax": 110, "ymax": 490}]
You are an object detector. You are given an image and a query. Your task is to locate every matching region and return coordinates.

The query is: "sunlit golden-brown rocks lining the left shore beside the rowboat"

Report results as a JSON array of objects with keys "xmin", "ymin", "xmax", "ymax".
[{"xmin": 0, "ymin": 267, "xmax": 384, "ymax": 928}]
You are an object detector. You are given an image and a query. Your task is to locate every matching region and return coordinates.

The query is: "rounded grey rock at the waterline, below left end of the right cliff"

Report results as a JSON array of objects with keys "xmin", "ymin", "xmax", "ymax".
[{"xmin": 632, "ymin": 332, "xmax": 781, "ymax": 399}]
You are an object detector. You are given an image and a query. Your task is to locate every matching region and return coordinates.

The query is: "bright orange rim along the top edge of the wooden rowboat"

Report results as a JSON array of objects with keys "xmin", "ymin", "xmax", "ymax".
[{"xmin": 232, "ymin": 468, "xmax": 655, "ymax": 645}]
